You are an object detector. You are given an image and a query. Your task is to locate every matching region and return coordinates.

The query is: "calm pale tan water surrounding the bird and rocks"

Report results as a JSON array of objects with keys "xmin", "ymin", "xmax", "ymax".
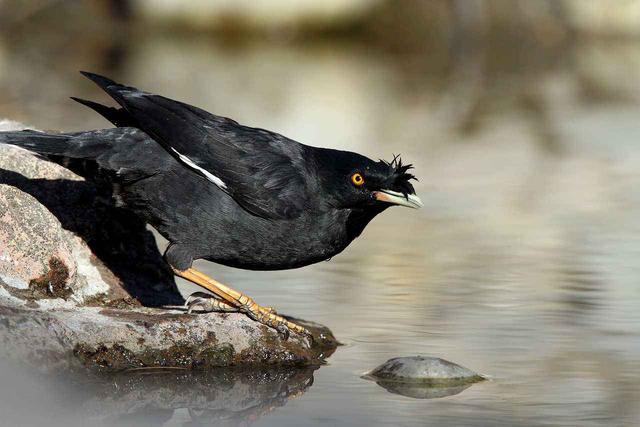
[{"xmin": 0, "ymin": 28, "xmax": 640, "ymax": 426}]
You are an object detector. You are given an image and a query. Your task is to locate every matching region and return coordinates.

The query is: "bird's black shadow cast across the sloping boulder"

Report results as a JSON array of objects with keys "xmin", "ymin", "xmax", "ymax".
[{"xmin": 0, "ymin": 169, "xmax": 184, "ymax": 307}]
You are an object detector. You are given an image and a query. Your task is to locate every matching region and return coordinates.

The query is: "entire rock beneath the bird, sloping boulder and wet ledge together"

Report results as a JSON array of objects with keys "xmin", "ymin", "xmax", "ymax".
[{"xmin": 0, "ymin": 121, "xmax": 337, "ymax": 371}]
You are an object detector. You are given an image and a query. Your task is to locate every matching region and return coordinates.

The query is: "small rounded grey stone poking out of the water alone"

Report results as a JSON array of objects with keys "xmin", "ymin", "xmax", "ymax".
[{"xmin": 364, "ymin": 356, "xmax": 485, "ymax": 399}]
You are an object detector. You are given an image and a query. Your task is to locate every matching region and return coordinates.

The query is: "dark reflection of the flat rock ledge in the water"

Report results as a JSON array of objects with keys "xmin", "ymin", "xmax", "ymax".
[{"xmin": 91, "ymin": 368, "xmax": 314, "ymax": 426}]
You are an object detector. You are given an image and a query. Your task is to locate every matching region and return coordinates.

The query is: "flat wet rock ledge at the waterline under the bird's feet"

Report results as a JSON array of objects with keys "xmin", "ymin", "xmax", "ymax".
[{"xmin": 0, "ymin": 304, "xmax": 335, "ymax": 372}]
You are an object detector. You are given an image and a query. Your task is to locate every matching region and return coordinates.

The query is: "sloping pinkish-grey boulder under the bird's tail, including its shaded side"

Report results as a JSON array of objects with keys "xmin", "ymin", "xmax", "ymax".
[{"xmin": 0, "ymin": 144, "xmax": 183, "ymax": 306}]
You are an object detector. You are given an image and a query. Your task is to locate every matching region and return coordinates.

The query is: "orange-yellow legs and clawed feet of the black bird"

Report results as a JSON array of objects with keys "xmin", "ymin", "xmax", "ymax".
[{"xmin": 173, "ymin": 268, "xmax": 312, "ymax": 337}]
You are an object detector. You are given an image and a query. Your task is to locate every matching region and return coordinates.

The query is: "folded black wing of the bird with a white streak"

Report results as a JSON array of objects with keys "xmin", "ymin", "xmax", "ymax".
[{"xmin": 82, "ymin": 72, "xmax": 309, "ymax": 219}]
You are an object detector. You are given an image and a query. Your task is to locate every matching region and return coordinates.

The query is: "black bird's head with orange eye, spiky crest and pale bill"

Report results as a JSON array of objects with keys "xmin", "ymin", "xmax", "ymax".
[{"xmin": 312, "ymin": 150, "xmax": 423, "ymax": 212}]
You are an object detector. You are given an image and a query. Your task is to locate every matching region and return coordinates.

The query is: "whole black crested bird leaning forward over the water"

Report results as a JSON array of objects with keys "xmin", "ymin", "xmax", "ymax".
[{"xmin": 0, "ymin": 72, "xmax": 422, "ymax": 342}]
